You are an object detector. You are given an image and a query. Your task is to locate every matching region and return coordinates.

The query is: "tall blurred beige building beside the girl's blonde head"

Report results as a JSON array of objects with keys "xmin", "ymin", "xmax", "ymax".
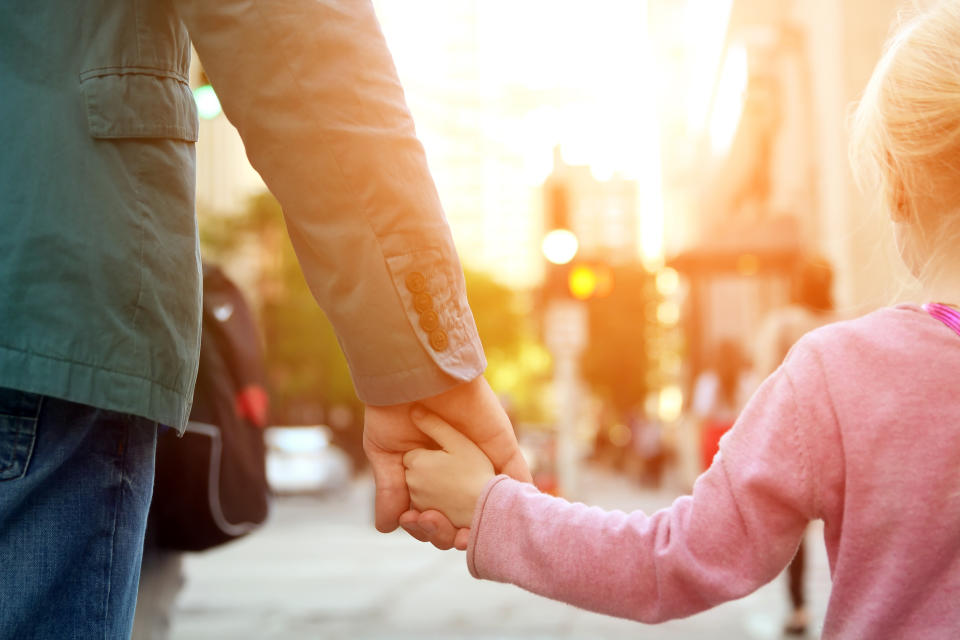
[{"xmin": 651, "ymin": 0, "xmax": 902, "ymax": 380}]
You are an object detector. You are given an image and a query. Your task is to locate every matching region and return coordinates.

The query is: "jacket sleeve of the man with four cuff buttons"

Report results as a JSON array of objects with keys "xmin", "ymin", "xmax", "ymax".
[{"xmin": 174, "ymin": 0, "xmax": 486, "ymax": 405}]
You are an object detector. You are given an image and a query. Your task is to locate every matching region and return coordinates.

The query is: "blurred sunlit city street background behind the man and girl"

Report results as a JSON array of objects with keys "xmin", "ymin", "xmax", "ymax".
[{"xmin": 173, "ymin": 0, "xmax": 922, "ymax": 639}]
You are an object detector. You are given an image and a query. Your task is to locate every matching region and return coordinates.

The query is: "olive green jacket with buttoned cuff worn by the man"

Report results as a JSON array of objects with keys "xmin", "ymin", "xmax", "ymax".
[{"xmin": 0, "ymin": 0, "xmax": 485, "ymax": 427}]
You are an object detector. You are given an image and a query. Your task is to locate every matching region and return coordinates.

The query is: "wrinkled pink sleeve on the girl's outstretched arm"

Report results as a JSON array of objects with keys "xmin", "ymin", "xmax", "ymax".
[{"xmin": 467, "ymin": 344, "xmax": 831, "ymax": 623}]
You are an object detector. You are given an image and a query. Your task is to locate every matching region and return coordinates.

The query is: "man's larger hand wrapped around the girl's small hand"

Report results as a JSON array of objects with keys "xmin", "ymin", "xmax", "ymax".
[{"xmin": 363, "ymin": 376, "xmax": 531, "ymax": 549}]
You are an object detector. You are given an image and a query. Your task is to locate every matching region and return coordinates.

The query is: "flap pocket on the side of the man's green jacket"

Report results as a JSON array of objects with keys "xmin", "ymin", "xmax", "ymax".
[{"xmin": 80, "ymin": 67, "xmax": 199, "ymax": 142}]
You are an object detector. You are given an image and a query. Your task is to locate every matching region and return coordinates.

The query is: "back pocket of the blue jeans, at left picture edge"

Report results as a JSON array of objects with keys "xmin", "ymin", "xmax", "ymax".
[{"xmin": 0, "ymin": 389, "xmax": 43, "ymax": 482}]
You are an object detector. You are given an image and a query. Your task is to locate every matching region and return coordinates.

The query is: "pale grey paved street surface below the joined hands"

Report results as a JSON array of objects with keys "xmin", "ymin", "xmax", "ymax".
[{"xmin": 173, "ymin": 470, "xmax": 830, "ymax": 640}]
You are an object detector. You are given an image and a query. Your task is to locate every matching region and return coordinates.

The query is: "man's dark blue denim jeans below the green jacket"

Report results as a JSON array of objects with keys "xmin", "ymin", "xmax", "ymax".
[{"xmin": 0, "ymin": 388, "xmax": 157, "ymax": 640}]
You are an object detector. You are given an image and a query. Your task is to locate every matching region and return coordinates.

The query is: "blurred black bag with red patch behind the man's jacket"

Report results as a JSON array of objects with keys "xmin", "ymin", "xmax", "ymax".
[{"xmin": 150, "ymin": 264, "xmax": 270, "ymax": 551}]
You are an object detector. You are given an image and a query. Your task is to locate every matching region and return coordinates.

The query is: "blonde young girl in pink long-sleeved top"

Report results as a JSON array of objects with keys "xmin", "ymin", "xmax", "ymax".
[{"xmin": 404, "ymin": 0, "xmax": 960, "ymax": 638}]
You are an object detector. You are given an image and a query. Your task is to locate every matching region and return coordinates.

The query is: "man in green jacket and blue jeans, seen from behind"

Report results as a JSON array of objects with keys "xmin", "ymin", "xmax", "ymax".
[{"xmin": 0, "ymin": 0, "xmax": 528, "ymax": 638}]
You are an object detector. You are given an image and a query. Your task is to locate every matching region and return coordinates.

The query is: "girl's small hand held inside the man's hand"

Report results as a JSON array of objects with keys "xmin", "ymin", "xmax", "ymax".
[{"xmin": 403, "ymin": 406, "xmax": 494, "ymax": 527}]
